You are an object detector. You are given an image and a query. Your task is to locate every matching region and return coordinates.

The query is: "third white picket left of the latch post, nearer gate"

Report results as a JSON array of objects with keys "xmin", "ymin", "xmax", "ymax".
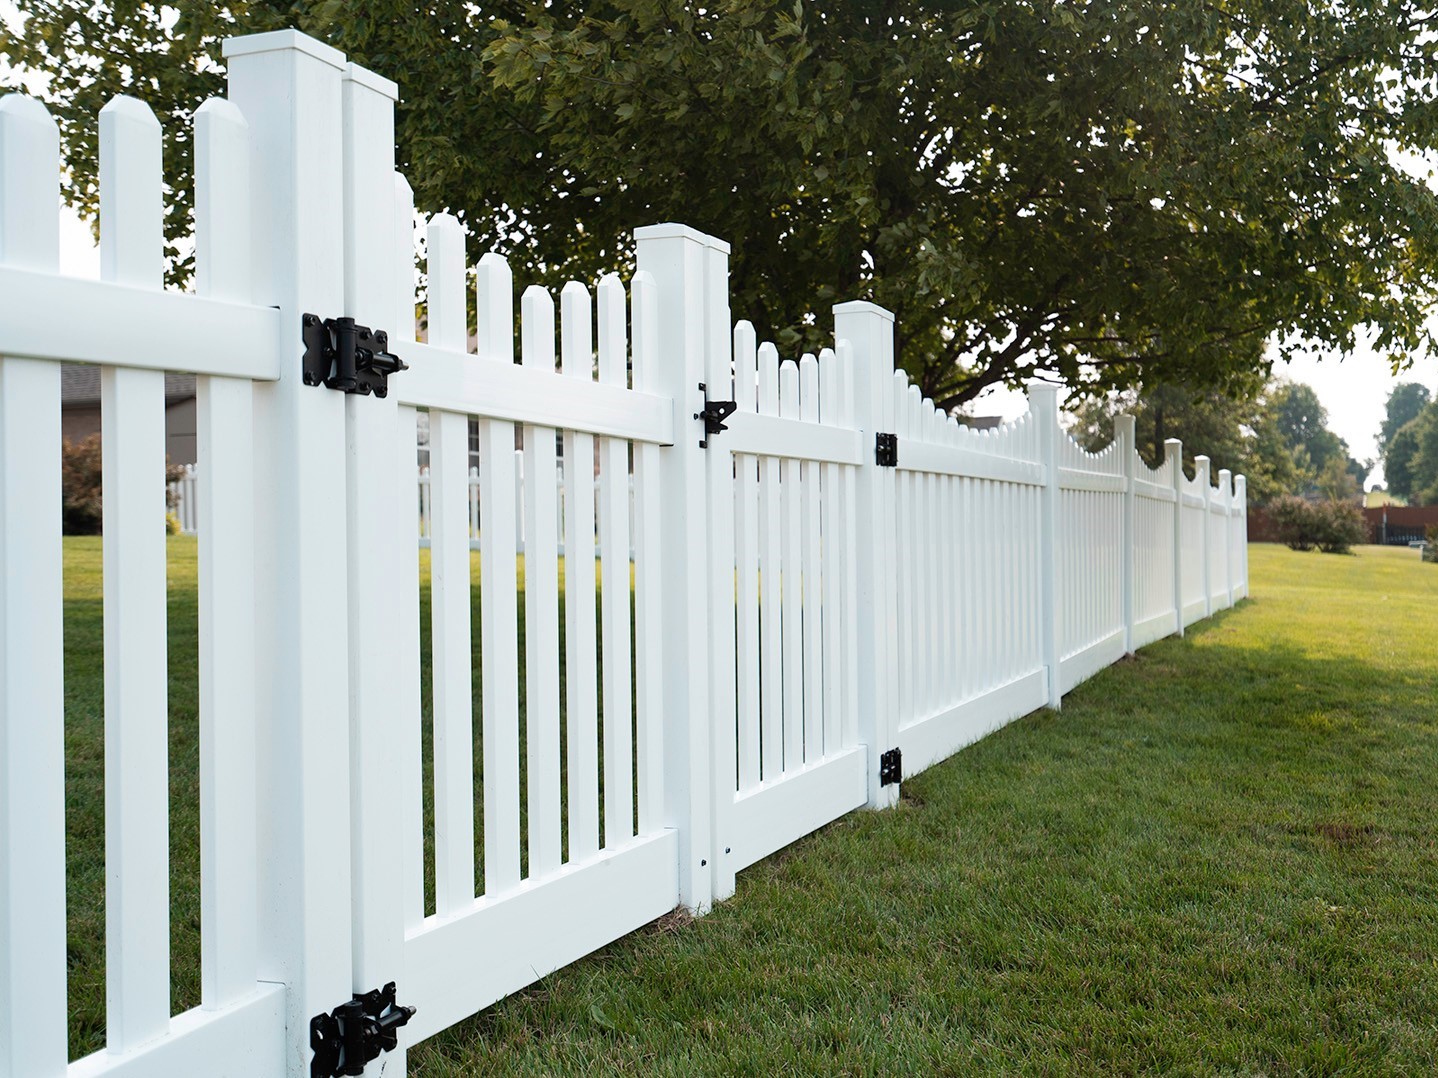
[{"xmin": 559, "ymin": 280, "xmax": 600, "ymax": 861}]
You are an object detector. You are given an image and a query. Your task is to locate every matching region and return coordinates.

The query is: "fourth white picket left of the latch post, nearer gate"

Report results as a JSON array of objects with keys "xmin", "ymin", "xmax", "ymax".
[{"xmin": 519, "ymin": 285, "xmax": 564, "ymax": 877}]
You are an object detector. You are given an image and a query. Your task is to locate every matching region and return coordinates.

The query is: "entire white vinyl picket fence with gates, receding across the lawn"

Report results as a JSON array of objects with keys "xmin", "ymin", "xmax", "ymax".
[{"xmin": 0, "ymin": 32, "xmax": 1247, "ymax": 1078}]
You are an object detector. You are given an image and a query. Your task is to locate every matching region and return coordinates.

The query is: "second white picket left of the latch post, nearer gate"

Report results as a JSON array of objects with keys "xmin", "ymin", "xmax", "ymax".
[{"xmin": 595, "ymin": 273, "xmax": 634, "ymax": 847}]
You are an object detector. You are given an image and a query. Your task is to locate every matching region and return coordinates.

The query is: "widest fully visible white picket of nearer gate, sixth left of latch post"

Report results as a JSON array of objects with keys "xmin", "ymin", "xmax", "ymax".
[{"xmin": 427, "ymin": 214, "xmax": 475, "ymax": 916}]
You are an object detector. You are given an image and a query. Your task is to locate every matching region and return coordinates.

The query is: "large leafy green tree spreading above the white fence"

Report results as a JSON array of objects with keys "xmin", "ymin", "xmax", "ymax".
[{"xmin": 8, "ymin": 0, "xmax": 1438, "ymax": 405}]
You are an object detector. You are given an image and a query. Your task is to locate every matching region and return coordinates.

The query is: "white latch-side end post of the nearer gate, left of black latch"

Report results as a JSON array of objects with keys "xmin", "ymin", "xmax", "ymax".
[{"xmin": 634, "ymin": 224, "xmax": 716, "ymax": 913}]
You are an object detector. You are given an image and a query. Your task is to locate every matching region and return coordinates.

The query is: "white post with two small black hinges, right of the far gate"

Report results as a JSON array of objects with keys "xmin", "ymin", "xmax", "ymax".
[{"xmin": 834, "ymin": 300, "xmax": 903, "ymax": 808}]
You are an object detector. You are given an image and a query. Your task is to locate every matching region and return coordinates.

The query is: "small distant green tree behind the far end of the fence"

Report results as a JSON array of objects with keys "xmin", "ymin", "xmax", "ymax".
[{"xmin": 1070, "ymin": 378, "xmax": 1307, "ymax": 505}]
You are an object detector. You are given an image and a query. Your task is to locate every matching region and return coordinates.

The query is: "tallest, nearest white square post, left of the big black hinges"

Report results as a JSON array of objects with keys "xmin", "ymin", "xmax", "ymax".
[{"xmin": 224, "ymin": 30, "xmax": 352, "ymax": 1075}]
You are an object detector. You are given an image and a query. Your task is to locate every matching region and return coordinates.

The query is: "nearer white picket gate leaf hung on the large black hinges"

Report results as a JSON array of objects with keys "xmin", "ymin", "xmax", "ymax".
[{"xmin": 336, "ymin": 58, "xmax": 679, "ymax": 1067}]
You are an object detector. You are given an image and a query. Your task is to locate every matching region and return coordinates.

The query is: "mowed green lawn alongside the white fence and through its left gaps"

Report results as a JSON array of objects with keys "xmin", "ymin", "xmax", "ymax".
[{"xmin": 56, "ymin": 539, "xmax": 1438, "ymax": 1078}]
